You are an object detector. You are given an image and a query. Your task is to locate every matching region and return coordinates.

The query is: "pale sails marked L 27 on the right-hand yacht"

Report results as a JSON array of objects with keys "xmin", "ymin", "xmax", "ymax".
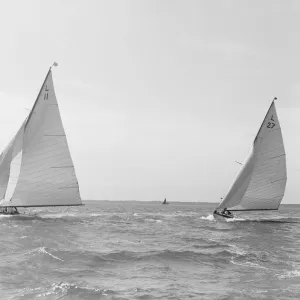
[{"xmin": 217, "ymin": 100, "xmax": 287, "ymax": 211}]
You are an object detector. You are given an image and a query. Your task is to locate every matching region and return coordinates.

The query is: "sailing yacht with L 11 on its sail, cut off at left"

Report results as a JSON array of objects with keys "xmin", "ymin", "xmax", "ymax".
[{"xmin": 0, "ymin": 63, "xmax": 82, "ymax": 214}]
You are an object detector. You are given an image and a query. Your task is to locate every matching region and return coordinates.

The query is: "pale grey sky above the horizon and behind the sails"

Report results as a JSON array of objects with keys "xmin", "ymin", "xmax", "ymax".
[{"xmin": 0, "ymin": 0, "xmax": 300, "ymax": 203}]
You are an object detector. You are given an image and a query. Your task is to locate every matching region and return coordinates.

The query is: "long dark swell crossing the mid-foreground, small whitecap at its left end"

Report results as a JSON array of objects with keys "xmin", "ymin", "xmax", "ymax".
[{"xmin": 31, "ymin": 244, "xmax": 276, "ymax": 267}]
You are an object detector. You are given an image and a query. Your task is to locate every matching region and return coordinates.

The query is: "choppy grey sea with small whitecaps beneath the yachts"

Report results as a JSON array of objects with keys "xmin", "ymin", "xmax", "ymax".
[{"xmin": 0, "ymin": 201, "xmax": 300, "ymax": 300}]
